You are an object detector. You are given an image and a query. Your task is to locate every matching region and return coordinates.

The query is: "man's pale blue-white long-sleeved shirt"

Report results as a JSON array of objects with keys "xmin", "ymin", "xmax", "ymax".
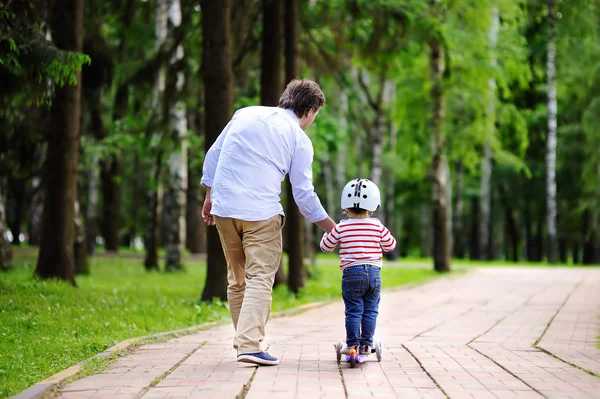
[{"xmin": 201, "ymin": 107, "xmax": 327, "ymax": 222}]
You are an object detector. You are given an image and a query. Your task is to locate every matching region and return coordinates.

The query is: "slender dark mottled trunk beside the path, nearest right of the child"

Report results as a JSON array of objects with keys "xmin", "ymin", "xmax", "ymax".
[{"xmin": 429, "ymin": 38, "xmax": 450, "ymax": 272}]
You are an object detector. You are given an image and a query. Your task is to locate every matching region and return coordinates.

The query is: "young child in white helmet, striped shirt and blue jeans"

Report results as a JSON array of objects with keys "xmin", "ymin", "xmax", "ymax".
[{"xmin": 321, "ymin": 179, "xmax": 396, "ymax": 363}]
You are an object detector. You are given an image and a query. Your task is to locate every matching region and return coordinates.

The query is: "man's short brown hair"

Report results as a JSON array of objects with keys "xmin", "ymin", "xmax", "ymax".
[{"xmin": 279, "ymin": 79, "xmax": 325, "ymax": 118}]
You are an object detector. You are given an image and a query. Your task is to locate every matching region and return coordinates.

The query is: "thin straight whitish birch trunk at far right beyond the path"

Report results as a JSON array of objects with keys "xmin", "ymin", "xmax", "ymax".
[{"xmin": 546, "ymin": 0, "xmax": 556, "ymax": 263}]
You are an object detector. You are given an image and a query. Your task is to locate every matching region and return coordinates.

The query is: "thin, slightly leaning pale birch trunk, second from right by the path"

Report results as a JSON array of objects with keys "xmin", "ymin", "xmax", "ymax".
[{"xmin": 479, "ymin": 6, "xmax": 500, "ymax": 260}]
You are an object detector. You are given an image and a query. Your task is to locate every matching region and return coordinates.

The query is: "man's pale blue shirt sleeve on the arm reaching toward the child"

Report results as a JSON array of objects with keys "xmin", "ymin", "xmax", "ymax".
[{"xmin": 289, "ymin": 137, "xmax": 327, "ymax": 223}]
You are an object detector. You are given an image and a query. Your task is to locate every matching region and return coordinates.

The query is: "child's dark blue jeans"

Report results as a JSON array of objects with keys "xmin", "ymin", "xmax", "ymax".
[{"xmin": 342, "ymin": 265, "xmax": 381, "ymax": 347}]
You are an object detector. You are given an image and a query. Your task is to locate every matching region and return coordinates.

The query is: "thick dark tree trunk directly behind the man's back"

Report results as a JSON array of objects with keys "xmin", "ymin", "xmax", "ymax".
[{"xmin": 202, "ymin": 0, "xmax": 233, "ymax": 300}]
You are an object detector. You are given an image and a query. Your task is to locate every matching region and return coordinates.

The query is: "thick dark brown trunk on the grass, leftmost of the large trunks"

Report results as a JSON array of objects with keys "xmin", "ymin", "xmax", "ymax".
[{"xmin": 35, "ymin": 0, "xmax": 83, "ymax": 285}]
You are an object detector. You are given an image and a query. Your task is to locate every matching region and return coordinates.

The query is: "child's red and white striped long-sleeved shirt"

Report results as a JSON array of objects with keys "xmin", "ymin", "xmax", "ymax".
[{"xmin": 321, "ymin": 218, "xmax": 396, "ymax": 269}]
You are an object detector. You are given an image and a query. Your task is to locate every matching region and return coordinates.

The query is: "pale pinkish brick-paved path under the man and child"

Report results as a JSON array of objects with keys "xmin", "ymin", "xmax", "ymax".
[{"xmin": 54, "ymin": 268, "xmax": 600, "ymax": 399}]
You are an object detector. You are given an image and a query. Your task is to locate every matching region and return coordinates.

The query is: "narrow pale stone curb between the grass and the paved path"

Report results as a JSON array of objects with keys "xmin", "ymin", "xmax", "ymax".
[{"xmin": 11, "ymin": 270, "xmax": 458, "ymax": 399}]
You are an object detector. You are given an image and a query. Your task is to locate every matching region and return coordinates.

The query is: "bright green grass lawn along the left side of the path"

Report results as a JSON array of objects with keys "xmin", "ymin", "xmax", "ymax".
[{"xmin": 0, "ymin": 248, "xmax": 436, "ymax": 397}]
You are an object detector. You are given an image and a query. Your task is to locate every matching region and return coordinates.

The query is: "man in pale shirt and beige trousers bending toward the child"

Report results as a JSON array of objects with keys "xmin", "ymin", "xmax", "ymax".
[{"xmin": 202, "ymin": 80, "xmax": 335, "ymax": 365}]
